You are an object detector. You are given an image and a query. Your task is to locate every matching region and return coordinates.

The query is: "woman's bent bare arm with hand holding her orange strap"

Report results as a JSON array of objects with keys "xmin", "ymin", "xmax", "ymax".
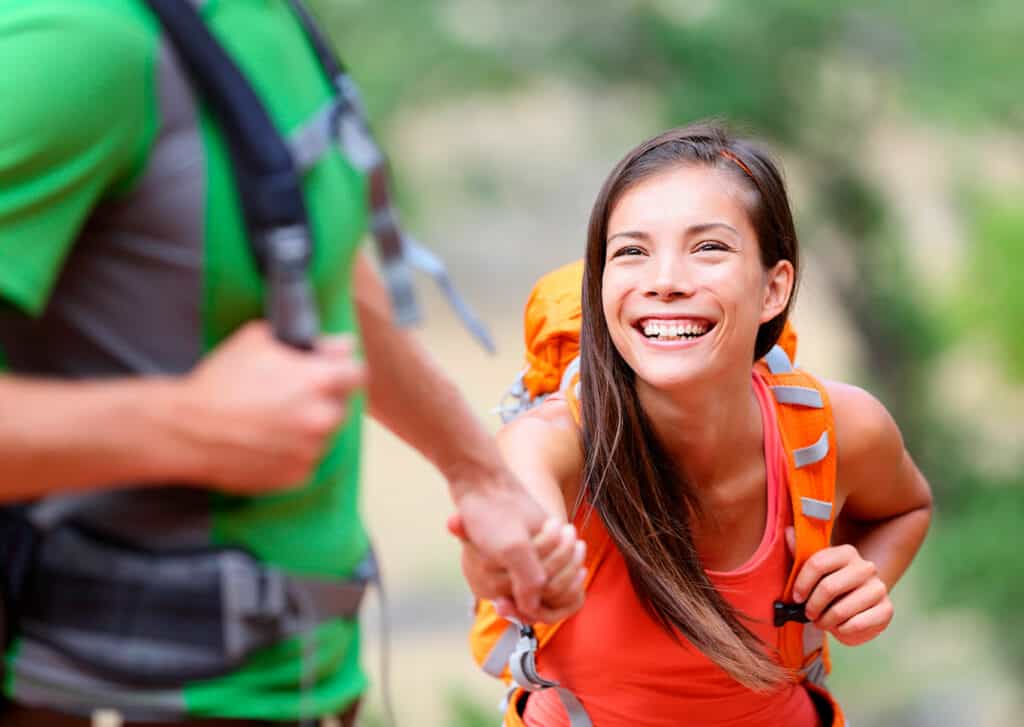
[{"xmin": 794, "ymin": 383, "xmax": 932, "ymax": 645}]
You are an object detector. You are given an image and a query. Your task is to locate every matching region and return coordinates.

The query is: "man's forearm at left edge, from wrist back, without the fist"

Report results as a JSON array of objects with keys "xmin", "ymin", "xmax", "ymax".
[{"xmin": 0, "ymin": 376, "xmax": 189, "ymax": 502}]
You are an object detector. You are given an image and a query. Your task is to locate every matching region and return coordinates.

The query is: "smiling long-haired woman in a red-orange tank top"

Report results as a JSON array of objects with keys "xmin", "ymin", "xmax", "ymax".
[{"xmin": 452, "ymin": 125, "xmax": 931, "ymax": 727}]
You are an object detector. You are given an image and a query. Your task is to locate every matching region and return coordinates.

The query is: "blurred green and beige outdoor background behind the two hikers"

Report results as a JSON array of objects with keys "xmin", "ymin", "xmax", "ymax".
[{"xmin": 313, "ymin": 0, "xmax": 1024, "ymax": 727}]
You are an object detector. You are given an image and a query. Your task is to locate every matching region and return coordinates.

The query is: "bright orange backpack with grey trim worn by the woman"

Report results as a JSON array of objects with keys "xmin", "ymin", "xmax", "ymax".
[{"xmin": 470, "ymin": 260, "xmax": 846, "ymax": 727}]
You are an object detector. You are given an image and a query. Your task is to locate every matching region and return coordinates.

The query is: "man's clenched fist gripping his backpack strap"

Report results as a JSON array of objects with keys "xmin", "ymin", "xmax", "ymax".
[{"xmin": 178, "ymin": 322, "xmax": 365, "ymax": 495}]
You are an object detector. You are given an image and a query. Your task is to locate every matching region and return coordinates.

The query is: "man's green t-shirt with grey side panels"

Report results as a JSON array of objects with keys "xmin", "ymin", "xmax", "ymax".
[{"xmin": 0, "ymin": 0, "xmax": 368, "ymax": 720}]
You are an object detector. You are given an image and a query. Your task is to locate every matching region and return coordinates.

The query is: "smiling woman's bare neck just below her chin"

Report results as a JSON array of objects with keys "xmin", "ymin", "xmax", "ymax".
[{"xmin": 638, "ymin": 369, "xmax": 763, "ymax": 490}]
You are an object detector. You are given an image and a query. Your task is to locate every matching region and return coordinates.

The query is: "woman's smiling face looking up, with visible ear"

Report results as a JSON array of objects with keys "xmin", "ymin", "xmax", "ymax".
[{"xmin": 601, "ymin": 165, "xmax": 793, "ymax": 390}]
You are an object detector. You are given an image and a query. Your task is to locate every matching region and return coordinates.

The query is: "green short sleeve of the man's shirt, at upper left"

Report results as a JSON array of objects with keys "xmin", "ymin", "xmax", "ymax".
[{"xmin": 0, "ymin": 0, "xmax": 156, "ymax": 315}]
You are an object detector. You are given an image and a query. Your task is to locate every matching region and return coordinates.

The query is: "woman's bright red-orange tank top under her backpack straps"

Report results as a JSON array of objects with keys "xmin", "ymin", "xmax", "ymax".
[{"xmin": 523, "ymin": 374, "xmax": 819, "ymax": 727}]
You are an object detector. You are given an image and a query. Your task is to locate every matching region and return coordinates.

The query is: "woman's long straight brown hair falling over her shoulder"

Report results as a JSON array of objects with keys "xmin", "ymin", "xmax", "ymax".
[{"xmin": 580, "ymin": 123, "xmax": 799, "ymax": 690}]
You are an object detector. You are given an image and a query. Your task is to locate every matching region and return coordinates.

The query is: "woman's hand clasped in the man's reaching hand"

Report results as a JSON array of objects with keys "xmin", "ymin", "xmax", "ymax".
[{"xmin": 447, "ymin": 515, "xmax": 587, "ymax": 624}]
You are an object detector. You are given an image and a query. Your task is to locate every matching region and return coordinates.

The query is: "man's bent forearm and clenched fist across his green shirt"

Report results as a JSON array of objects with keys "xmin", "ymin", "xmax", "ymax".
[{"xmin": 0, "ymin": 322, "xmax": 364, "ymax": 502}]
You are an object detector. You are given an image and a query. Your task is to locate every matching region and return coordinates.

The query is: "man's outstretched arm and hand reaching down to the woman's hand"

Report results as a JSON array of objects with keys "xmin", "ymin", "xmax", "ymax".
[{"xmin": 353, "ymin": 255, "xmax": 546, "ymax": 618}]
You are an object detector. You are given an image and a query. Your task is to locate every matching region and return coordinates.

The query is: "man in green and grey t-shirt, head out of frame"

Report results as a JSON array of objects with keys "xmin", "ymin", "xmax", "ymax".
[{"xmin": 0, "ymin": 0, "xmax": 577, "ymax": 726}]
